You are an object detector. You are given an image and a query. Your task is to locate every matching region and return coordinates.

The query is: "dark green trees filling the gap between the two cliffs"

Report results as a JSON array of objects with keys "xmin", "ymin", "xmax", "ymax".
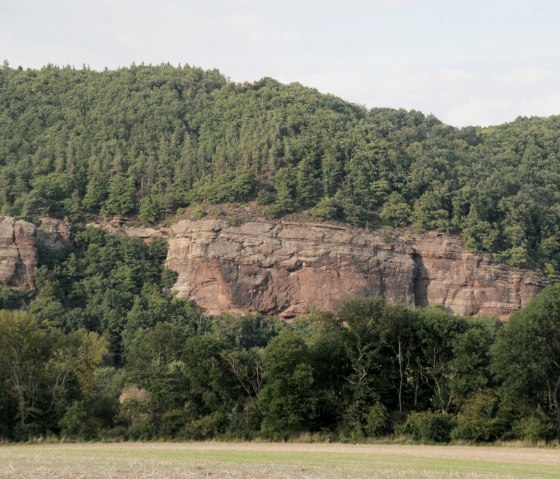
[{"xmin": 30, "ymin": 228, "xmax": 186, "ymax": 364}]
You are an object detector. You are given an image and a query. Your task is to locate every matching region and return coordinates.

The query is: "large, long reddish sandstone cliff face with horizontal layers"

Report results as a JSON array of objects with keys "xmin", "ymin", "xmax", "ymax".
[{"xmin": 167, "ymin": 219, "xmax": 546, "ymax": 319}]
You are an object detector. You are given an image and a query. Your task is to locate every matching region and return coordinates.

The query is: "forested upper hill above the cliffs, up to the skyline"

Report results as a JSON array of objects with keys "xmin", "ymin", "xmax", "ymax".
[{"xmin": 0, "ymin": 65, "xmax": 560, "ymax": 277}]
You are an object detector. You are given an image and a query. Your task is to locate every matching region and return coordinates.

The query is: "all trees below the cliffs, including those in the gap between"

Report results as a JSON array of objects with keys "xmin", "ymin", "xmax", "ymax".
[{"xmin": 0, "ymin": 232, "xmax": 560, "ymax": 442}]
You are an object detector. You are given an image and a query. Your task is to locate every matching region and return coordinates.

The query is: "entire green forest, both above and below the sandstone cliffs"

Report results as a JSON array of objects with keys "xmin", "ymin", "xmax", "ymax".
[{"xmin": 0, "ymin": 63, "xmax": 560, "ymax": 442}]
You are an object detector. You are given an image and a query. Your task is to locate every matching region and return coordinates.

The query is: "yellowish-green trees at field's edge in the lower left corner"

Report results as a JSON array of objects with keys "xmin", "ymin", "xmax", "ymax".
[{"xmin": 0, "ymin": 310, "xmax": 105, "ymax": 439}]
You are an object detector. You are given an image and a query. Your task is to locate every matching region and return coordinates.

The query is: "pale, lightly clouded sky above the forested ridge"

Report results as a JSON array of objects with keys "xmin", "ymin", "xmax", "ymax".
[{"xmin": 0, "ymin": 0, "xmax": 560, "ymax": 126}]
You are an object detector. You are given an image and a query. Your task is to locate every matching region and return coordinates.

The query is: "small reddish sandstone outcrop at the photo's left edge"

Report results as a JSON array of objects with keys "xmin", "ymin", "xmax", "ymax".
[{"xmin": 0, "ymin": 216, "xmax": 37, "ymax": 288}]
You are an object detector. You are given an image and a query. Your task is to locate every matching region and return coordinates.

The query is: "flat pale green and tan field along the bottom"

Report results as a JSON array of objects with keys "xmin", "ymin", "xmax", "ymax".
[{"xmin": 0, "ymin": 443, "xmax": 560, "ymax": 479}]
